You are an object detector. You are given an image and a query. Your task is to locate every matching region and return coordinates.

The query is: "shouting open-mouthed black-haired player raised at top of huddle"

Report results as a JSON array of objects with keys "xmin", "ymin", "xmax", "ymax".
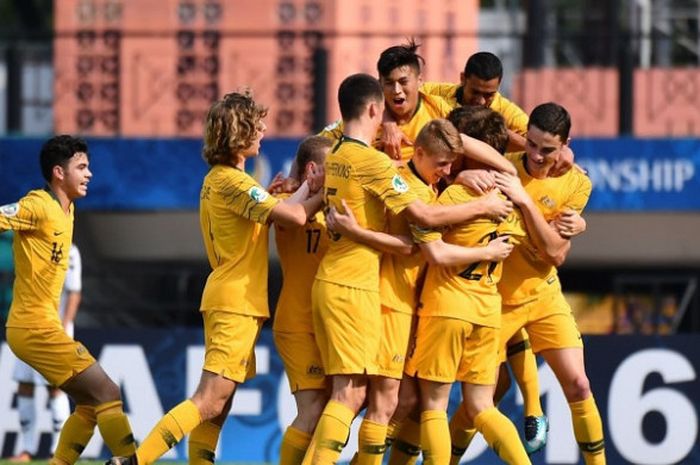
[{"xmin": 322, "ymin": 41, "xmax": 452, "ymax": 163}]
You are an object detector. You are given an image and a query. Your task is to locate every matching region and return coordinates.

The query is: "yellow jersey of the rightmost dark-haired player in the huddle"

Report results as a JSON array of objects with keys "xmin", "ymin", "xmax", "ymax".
[{"xmin": 498, "ymin": 152, "xmax": 591, "ymax": 305}]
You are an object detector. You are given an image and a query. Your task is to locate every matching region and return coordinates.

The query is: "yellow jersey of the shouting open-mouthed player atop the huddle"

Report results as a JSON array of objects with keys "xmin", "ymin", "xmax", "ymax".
[{"xmin": 319, "ymin": 93, "xmax": 453, "ymax": 162}]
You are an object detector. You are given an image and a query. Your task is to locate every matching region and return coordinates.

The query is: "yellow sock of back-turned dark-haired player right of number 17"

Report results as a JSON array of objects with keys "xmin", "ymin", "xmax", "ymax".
[{"xmin": 312, "ymin": 400, "xmax": 355, "ymax": 465}]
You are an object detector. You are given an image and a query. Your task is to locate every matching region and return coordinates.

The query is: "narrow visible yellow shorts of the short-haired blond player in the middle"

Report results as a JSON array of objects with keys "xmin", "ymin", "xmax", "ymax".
[{"xmin": 377, "ymin": 306, "xmax": 413, "ymax": 379}]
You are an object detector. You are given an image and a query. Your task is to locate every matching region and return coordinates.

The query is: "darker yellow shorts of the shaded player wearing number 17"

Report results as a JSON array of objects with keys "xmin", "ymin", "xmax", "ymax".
[{"xmin": 272, "ymin": 331, "xmax": 326, "ymax": 392}]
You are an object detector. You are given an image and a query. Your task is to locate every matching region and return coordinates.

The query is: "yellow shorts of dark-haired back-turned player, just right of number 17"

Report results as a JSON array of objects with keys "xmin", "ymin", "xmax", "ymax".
[{"xmin": 311, "ymin": 279, "xmax": 382, "ymax": 375}]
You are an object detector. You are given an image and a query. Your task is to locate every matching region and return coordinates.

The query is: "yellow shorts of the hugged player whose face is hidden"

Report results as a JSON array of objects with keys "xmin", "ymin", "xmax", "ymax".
[{"xmin": 406, "ymin": 316, "xmax": 500, "ymax": 385}]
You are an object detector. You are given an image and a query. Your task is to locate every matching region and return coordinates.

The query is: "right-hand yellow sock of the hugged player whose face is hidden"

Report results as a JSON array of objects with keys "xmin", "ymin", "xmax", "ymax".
[{"xmin": 474, "ymin": 407, "xmax": 530, "ymax": 465}]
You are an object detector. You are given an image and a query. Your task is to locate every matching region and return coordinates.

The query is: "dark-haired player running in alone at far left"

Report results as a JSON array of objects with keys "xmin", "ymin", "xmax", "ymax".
[{"xmin": 0, "ymin": 135, "xmax": 135, "ymax": 465}]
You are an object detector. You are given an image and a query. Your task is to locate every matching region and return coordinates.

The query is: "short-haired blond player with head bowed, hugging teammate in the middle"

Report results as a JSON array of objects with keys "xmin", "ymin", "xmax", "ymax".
[{"xmin": 328, "ymin": 119, "xmax": 513, "ymax": 463}]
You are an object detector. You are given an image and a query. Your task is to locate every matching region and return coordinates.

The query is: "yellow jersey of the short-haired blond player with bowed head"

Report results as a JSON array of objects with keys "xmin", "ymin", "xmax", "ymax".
[{"xmin": 379, "ymin": 162, "xmax": 437, "ymax": 314}]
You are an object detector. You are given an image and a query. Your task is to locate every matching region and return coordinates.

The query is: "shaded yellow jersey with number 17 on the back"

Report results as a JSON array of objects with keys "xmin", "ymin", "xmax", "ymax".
[{"xmin": 272, "ymin": 197, "xmax": 328, "ymax": 333}]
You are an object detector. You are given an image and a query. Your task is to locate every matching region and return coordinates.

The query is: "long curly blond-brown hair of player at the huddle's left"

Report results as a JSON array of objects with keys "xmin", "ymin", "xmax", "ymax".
[{"xmin": 202, "ymin": 91, "xmax": 267, "ymax": 166}]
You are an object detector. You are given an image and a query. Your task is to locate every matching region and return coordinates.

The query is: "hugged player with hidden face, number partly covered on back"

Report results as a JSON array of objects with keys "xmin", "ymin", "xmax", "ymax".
[{"xmin": 406, "ymin": 131, "xmax": 530, "ymax": 465}]
